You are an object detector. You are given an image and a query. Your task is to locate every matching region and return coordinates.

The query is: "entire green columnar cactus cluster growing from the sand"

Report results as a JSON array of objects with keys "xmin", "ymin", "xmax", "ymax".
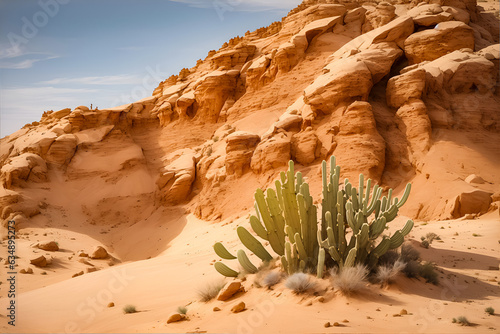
[{"xmin": 214, "ymin": 156, "xmax": 413, "ymax": 277}]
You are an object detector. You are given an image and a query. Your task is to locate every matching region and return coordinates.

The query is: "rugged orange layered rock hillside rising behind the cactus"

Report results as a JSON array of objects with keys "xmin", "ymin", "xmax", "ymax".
[{"xmin": 0, "ymin": 0, "xmax": 500, "ymax": 232}]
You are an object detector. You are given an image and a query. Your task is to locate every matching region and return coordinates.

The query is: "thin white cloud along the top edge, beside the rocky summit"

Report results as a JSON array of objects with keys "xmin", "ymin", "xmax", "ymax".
[{"xmin": 170, "ymin": 0, "xmax": 302, "ymax": 11}]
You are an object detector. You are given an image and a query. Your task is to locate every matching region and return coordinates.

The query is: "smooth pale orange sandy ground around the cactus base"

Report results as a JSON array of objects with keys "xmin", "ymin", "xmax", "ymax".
[{"xmin": 0, "ymin": 212, "xmax": 500, "ymax": 333}]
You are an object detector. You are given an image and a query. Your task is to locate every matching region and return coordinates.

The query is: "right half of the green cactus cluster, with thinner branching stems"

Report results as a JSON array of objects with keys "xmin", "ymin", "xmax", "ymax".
[{"xmin": 318, "ymin": 156, "xmax": 413, "ymax": 276}]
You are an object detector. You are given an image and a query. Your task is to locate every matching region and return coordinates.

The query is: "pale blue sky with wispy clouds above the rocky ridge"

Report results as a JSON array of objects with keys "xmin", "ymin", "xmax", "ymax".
[{"xmin": 0, "ymin": 0, "xmax": 301, "ymax": 137}]
